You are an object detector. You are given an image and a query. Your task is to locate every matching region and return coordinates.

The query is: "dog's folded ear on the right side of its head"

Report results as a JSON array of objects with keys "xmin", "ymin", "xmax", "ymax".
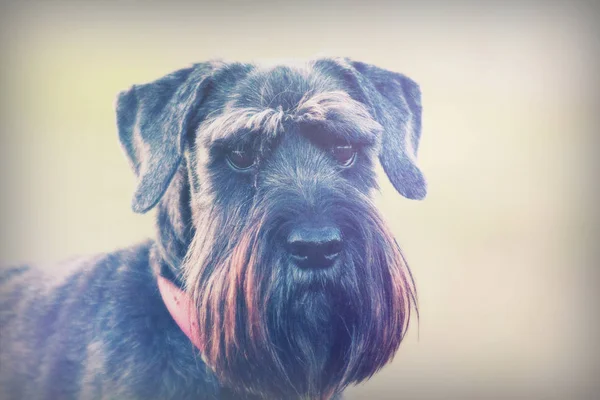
[{"xmin": 350, "ymin": 61, "xmax": 427, "ymax": 200}]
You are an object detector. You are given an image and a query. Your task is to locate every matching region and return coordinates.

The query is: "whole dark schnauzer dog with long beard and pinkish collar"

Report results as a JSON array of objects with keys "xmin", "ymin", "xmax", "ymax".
[{"xmin": 0, "ymin": 58, "xmax": 427, "ymax": 400}]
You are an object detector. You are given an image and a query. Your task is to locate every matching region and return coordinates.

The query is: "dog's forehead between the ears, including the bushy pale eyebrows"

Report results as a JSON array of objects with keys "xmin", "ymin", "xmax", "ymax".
[{"xmin": 198, "ymin": 62, "xmax": 382, "ymax": 149}]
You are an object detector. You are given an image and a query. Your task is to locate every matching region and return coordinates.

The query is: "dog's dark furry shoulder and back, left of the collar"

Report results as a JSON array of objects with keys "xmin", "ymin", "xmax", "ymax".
[{"xmin": 0, "ymin": 242, "xmax": 218, "ymax": 399}]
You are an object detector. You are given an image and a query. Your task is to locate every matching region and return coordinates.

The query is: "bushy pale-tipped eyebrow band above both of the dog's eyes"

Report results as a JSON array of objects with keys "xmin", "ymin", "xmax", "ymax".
[{"xmin": 198, "ymin": 91, "xmax": 383, "ymax": 144}]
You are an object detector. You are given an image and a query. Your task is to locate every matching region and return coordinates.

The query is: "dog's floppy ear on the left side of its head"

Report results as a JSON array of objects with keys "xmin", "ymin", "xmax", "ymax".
[{"xmin": 116, "ymin": 63, "xmax": 212, "ymax": 213}]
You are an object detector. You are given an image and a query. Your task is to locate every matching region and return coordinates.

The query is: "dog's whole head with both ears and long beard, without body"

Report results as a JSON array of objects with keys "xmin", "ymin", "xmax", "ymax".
[{"xmin": 117, "ymin": 59, "xmax": 426, "ymax": 399}]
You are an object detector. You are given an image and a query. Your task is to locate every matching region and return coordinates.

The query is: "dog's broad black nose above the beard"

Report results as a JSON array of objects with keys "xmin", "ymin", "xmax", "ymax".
[{"xmin": 287, "ymin": 226, "xmax": 342, "ymax": 268}]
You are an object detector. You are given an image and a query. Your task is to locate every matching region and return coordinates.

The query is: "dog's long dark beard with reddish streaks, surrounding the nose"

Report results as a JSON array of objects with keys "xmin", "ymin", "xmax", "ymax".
[{"xmin": 184, "ymin": 191, "xmax": 415, "ymax": 399}]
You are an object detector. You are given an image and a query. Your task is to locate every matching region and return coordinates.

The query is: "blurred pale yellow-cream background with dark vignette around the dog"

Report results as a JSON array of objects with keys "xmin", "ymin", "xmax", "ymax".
[{"xmin": 0, "ymin": 1, "xmax": 600, "ymax": 400}]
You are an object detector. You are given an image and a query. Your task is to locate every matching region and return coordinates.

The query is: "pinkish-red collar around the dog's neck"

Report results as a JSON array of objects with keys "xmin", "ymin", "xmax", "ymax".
[{"xmin": 158, "ymin": 275, "xmax": 201, "ymax": 350}]
